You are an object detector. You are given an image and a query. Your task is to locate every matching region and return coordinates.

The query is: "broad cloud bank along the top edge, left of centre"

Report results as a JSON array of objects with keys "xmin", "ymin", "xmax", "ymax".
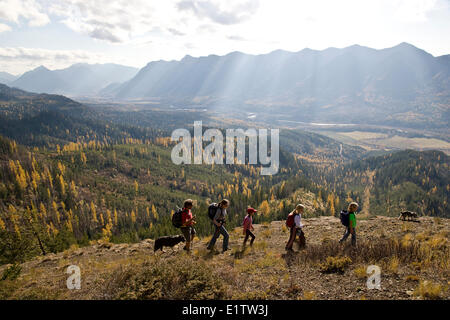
[{"xmin": 48, "ymin": 0, "xmax": 260, "ymax": 43}]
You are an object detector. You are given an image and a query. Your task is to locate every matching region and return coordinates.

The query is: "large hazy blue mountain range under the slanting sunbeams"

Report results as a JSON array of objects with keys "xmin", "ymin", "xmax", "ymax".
[{"xmin": 109, "ymin": 43, "xmax": 450, "ymax": 127}]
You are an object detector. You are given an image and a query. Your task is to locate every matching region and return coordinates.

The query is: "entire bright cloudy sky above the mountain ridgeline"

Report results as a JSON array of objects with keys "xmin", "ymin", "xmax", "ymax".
[{"xmin": 0, "ymin": 0, "xmax": 450, "ymax": 75}]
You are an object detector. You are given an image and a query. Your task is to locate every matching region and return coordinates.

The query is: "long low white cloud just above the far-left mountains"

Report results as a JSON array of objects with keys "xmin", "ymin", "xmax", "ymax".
[{"xmin": 0, "ymin": 47, "xmax": 111, "ymax": 74}]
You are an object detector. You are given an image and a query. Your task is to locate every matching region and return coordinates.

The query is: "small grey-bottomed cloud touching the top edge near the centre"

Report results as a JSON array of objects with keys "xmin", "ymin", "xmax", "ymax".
[{"xmin": 177, "ymin": 0, "xmax": 259, "ymax": 25}]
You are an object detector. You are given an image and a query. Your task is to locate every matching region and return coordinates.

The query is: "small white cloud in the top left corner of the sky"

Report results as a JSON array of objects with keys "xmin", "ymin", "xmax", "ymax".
[{"xmin": 0, "ymin": 0, "xmax": 50, "ymax": 27}]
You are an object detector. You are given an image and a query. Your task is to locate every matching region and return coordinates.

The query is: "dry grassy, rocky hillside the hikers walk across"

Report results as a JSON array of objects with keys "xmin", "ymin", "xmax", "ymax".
[{"xmin": 0, "ymin": 216, "xmax": 450, "ymax": 299}]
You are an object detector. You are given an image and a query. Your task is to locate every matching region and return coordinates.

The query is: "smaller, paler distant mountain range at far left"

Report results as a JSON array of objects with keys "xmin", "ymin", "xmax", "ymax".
[{"xmin": 9, "ymin": 63, "xmax": 138, "ymax": 96}]
